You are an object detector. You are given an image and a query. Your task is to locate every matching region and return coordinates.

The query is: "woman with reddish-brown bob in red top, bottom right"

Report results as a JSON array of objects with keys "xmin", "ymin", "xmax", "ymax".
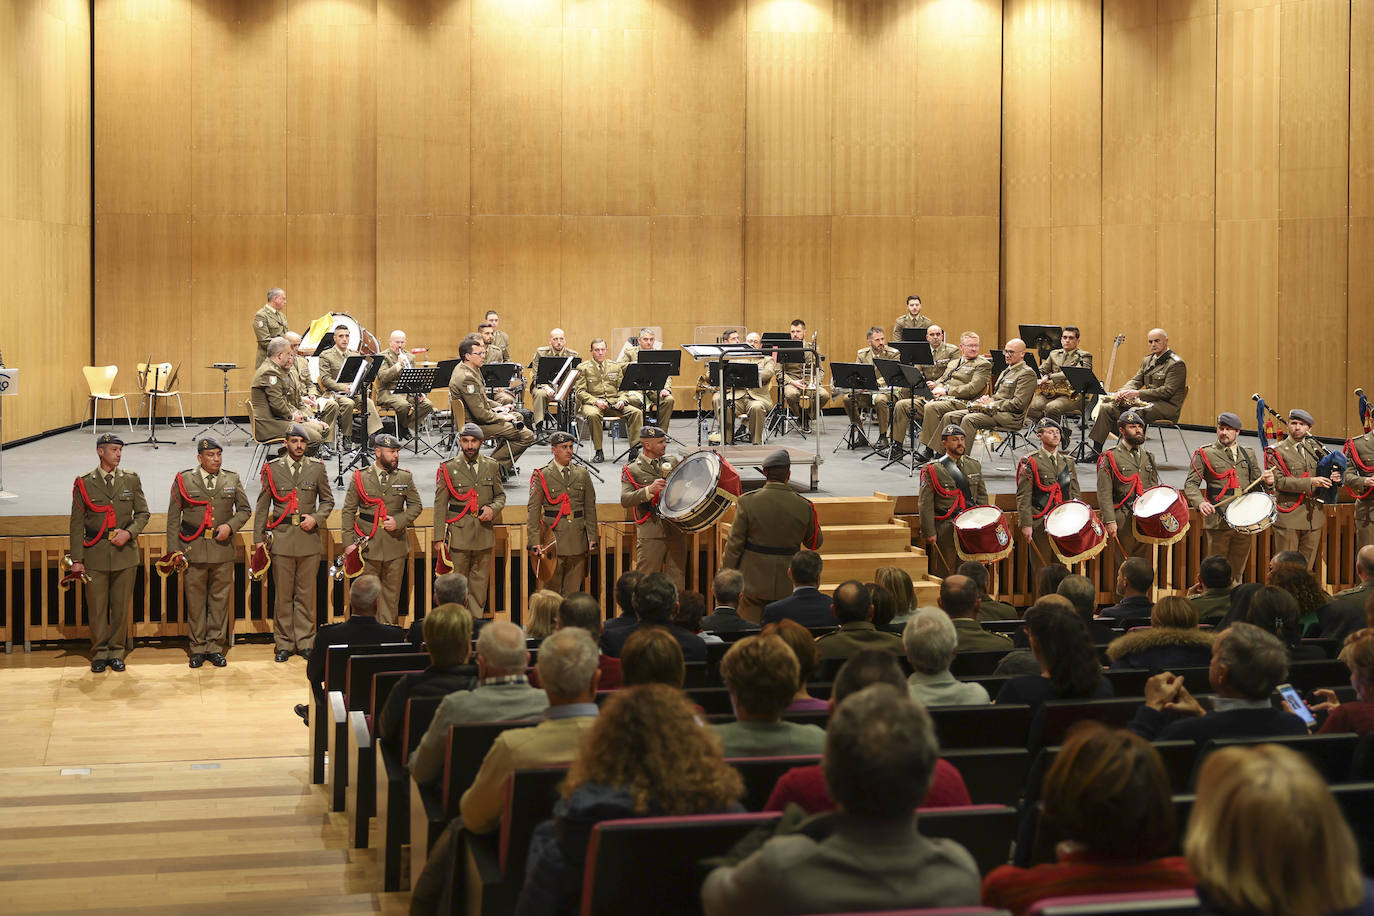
[{"xmin": 982, "ymin": 721, "xmax": 1193, "ymax": 916}]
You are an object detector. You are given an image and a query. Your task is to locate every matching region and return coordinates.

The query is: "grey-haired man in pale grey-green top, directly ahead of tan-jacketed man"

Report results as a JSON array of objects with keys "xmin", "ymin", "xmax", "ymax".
[{"xmin": 409, "ymin": 620, "xmax": 548, "ymax": 784}]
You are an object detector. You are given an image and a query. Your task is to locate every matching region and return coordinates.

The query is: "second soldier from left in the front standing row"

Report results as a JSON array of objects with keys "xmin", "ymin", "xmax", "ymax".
[{"xmin": 168, "ymin": 437, "xmax": 253, "ymax": 667}]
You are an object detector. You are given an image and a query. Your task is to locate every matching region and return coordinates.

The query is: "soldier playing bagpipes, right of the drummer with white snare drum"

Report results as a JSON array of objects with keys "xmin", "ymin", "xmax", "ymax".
[{"xmin": 1265, "ymin": 409, "xmax": 1341, "ymax": 569}]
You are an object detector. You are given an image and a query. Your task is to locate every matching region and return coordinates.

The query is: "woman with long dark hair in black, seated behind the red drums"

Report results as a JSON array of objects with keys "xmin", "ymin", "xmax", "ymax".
[{"xmin": 996, "ymin": 595, "xmax": 1113, "ymax": 706}]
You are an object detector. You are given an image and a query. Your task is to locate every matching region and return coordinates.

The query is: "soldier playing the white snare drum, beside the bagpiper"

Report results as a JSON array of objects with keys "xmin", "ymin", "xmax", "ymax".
[{"xmin": 1183, "ymin": 411, "xmax": 1274, "ymax": 585}]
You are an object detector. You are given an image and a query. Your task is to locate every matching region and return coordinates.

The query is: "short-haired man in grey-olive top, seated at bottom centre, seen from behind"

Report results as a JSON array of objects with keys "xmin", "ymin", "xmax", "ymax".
[{"xmin": 701, "ymin": 684, "xmax": 978, "ymax": 916}]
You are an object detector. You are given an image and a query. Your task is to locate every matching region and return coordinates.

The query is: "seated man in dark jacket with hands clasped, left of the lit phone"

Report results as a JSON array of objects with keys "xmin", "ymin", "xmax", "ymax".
[{"xmin": 1131, "ymin": 622, "xmax": 1307, "ymax": 746}]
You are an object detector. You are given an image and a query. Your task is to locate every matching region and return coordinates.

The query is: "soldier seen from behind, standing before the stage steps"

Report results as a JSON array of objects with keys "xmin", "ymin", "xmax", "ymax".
[{"xmin": 720, "ymin": 450, "xmax": 824, "ymax": 623}]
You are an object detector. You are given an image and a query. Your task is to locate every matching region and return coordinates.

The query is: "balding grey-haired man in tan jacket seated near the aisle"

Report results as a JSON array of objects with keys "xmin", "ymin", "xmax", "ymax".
[{"xmin": 459, "ymin": 628, "xmax": 600, "ymax": 834}]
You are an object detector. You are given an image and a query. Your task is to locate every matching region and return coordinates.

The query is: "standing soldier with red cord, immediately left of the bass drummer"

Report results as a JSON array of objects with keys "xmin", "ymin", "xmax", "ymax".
[{"xmin": 525, "ymin": 431, "xmax": 596, "ymax": 597}]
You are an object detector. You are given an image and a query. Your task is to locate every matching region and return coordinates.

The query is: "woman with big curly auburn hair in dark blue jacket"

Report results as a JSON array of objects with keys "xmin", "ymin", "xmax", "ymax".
[{"xmin": 515, "ymin": 684, "xmax": 745, "ymax": 916}]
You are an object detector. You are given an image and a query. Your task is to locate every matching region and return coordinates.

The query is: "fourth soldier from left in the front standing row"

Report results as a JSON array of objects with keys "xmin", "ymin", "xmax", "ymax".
[{"xmin": 342, "ymin": 433, "xmax": 422, "ymax": 625}]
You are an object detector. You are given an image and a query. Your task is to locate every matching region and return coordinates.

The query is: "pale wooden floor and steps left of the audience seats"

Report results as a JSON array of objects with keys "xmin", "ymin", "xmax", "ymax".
[{"xmin": 0, "ymin": 644, "xmax": 408, "ymax": 913}]
